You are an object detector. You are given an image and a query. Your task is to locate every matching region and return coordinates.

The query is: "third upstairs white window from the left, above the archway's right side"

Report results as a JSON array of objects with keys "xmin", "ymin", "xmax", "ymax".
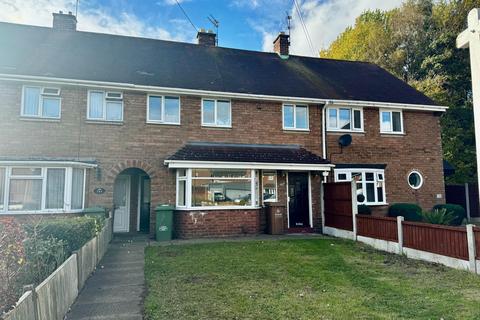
[{"xmin": 147, "ymin": 95, "xmax": 180, "ymax": 124}]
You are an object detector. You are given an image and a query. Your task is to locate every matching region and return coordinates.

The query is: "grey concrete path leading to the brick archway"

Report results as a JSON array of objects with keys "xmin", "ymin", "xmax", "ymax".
[{"xmin": 66, "ymin": 235, "xmax": 148, "ymax": 320}]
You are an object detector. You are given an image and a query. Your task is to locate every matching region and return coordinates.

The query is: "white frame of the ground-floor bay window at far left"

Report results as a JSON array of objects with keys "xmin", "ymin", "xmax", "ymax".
[{"xmin": 0, "ymin": 164, "xmax": 87, "ymax": 216}]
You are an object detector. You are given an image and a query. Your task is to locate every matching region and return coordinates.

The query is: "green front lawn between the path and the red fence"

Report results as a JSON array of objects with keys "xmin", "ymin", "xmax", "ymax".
[{"xmin": 145, "ymin": 238, "xmax": 480, "ymax": 320}]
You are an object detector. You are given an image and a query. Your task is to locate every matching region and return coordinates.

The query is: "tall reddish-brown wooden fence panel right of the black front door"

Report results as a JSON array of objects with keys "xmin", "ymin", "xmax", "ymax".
[{"xmin": 323, "ymin": 182, "xmax": 353, "ymax": 231}]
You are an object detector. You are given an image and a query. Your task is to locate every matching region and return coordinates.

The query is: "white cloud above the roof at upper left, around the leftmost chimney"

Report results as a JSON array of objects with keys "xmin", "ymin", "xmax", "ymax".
[{"xmin": 0, "ymin": 0, "xmax": 193, "ymax": 41}]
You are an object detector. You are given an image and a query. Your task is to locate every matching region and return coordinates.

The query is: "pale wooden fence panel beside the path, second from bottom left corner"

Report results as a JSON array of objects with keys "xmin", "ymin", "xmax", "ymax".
[{"xmin": 35, "ymin": 254, "xmax": 78, "ymax": 320}]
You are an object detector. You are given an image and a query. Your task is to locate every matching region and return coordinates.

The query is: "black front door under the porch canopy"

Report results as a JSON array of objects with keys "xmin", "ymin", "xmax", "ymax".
[{"xmin": 288, "ymin": 172, "xmax": 310, "ymax": 228}]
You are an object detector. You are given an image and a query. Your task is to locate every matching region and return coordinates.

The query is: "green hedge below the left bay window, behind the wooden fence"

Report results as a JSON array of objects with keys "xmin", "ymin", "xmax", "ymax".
[{"xmin": 26, "ymin": 217, "xmax": 101, "ymax": 256}]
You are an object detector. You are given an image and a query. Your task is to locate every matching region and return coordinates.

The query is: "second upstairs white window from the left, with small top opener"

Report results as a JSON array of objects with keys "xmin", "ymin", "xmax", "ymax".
[{"xmin": 87, "ymin": 90, "xmax": 123, "ymax": 122}]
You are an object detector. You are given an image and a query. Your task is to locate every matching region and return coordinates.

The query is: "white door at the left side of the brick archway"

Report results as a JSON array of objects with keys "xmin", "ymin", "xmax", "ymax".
[{"xmin": 113, "ymin": 176, "xmax": 130, "ymax": 232}]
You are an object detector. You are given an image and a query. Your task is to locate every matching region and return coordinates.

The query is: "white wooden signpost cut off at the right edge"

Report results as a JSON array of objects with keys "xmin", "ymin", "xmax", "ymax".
[{"xmin": 457, "ymin": 8, "xmax": 480, "ymax": 208}]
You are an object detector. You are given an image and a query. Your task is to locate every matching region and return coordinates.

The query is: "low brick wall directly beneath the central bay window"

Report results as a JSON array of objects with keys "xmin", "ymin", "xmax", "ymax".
[{"xmin": 174, "ymin": 209, "xmax": 263, "ymax": 239}]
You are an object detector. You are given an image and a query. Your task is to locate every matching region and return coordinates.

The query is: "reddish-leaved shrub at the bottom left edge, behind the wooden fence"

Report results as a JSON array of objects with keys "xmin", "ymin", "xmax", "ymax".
[{"xmin": 0, "ymin": 218, "xmax": 25, "ymax": 315}]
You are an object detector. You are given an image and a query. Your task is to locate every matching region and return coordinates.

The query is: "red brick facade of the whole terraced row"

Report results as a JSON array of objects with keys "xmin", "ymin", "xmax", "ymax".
[{"xmin": 0, "ymin": 82, "xmax": 444, "ymax": 237}]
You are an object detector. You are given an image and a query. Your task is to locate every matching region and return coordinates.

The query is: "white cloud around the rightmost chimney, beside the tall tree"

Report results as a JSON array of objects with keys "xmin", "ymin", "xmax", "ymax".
[{"xmin": 260, "ymin": 0, "xmax": 403, "ymax": 56}]
